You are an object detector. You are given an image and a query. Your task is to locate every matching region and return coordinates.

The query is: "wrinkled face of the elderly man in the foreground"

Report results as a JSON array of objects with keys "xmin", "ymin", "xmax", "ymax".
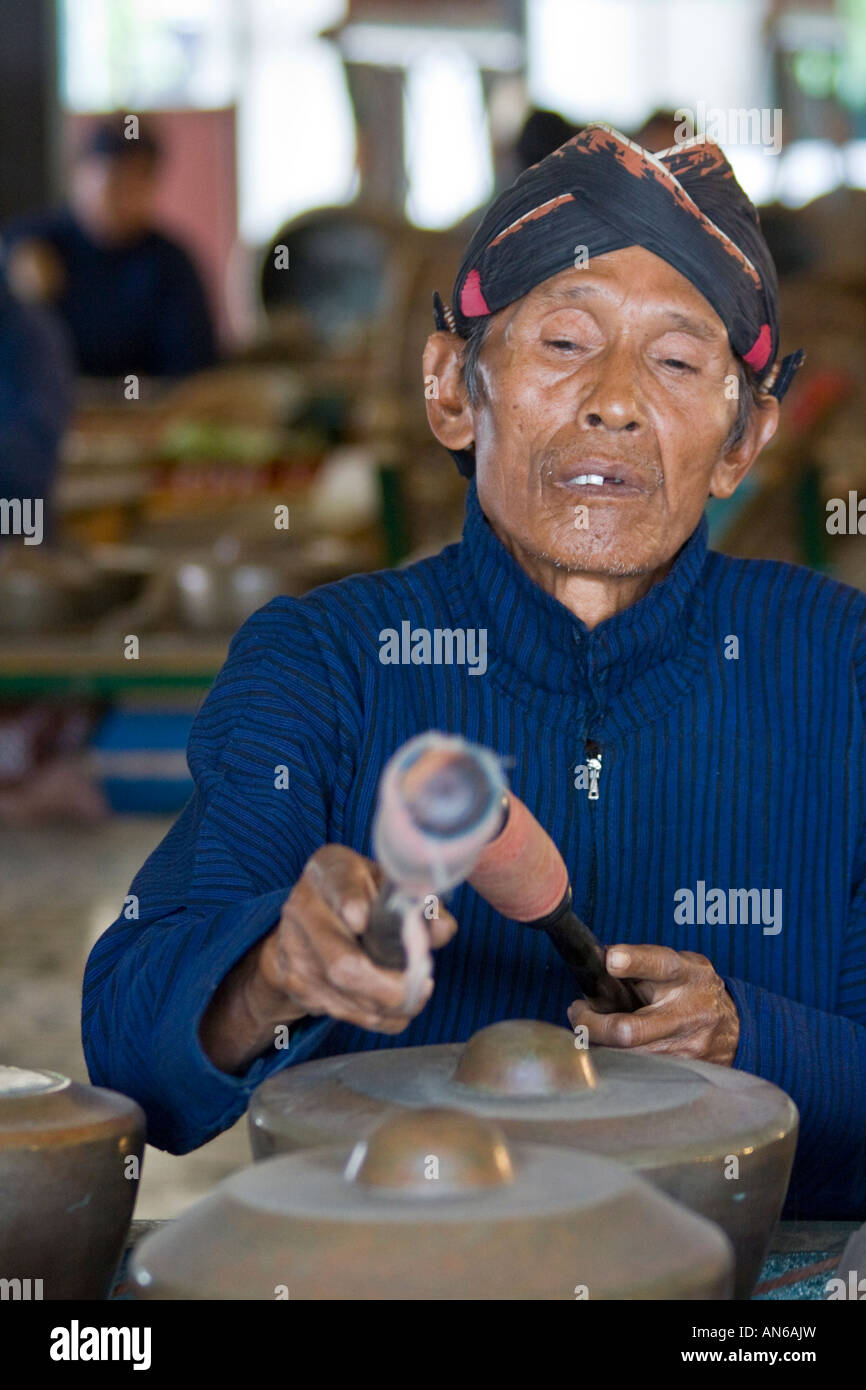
[{"xmin": 471, "ymin": 246, "xmax": 767, "ymax": 575}]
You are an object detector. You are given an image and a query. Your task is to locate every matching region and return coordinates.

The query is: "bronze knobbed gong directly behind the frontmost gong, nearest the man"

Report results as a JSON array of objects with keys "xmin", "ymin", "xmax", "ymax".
[{"xmin": 249, "ymin": 1019, "xmax": 798, "ymax": 1298}]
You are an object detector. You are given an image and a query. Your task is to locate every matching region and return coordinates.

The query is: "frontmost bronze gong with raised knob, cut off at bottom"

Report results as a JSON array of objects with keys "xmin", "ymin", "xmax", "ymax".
[{"xmin": 129, "ymin": 1109, "xmax": 731, "ymax": 1301}]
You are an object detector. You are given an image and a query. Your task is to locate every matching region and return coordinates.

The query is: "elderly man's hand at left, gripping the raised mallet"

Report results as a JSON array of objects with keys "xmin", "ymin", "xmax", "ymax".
[{"xmin": 200, "ymin": 845, "xmax": 457, "ymax": 1073}]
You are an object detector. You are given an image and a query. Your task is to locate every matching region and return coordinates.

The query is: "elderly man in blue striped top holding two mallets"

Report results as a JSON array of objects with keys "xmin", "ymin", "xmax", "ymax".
[{"xmin": 83, "ymin": 125, "xmax": 866, "ymax": 1216}]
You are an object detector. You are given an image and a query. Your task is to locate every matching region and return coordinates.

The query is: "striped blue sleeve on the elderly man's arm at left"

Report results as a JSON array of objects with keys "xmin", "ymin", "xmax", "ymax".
[{"xmin": 82, "ymin": 598, "xmax": 357, "ymax": 1154}]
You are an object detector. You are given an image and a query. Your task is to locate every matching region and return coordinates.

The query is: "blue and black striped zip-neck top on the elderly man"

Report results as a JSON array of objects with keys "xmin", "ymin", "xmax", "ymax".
[{"xmin": 82, "ymin": 484, "xmax": 866, "ymax": 1218}]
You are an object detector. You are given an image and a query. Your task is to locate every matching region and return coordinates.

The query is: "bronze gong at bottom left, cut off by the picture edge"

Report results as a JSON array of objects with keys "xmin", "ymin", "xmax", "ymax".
[{"xmin": 0, "ymin": 1066, "xmax": 145, "ymax": 1300}]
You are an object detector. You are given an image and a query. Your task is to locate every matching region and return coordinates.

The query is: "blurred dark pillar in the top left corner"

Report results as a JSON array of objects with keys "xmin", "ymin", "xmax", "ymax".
[{"xmin": 0, "ymin": 0, "xmax": 60, "ymax": 221}]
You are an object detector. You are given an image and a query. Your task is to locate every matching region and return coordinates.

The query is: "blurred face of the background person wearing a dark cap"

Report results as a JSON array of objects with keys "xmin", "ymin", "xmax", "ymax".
[{"xmin": 72, "ymin": 154, "xmax": 157, "ymax": 245}]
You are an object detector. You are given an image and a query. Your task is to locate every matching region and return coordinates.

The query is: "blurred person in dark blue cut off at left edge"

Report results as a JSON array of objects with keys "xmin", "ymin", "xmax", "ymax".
[{"xmin": 0, "ymin": 266, "xmax": 72, "ymax": 549}]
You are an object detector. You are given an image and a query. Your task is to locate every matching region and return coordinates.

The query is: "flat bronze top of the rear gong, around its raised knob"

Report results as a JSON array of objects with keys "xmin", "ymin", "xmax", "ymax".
[{"xmin": 249, "ymin": 1024, "xmax": 798, "ymax": 1169}]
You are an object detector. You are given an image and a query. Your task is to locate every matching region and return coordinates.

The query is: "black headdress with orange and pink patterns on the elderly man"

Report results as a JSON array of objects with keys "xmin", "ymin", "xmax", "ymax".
[{"xmin": 434, "ymin": 122, "xmax": 803, "ymax": 477}]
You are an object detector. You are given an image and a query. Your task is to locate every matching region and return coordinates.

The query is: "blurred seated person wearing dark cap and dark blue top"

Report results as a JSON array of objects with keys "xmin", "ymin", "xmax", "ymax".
[{"xmin": 1, "ymin": 118, "xmax": 217, "ymax": 377}]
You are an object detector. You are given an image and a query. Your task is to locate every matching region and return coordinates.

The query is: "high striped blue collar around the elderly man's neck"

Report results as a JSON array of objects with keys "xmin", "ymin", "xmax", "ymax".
[{"xmin": 457, "ymin": 480, "xmax": 708, "ymax": 709}]
